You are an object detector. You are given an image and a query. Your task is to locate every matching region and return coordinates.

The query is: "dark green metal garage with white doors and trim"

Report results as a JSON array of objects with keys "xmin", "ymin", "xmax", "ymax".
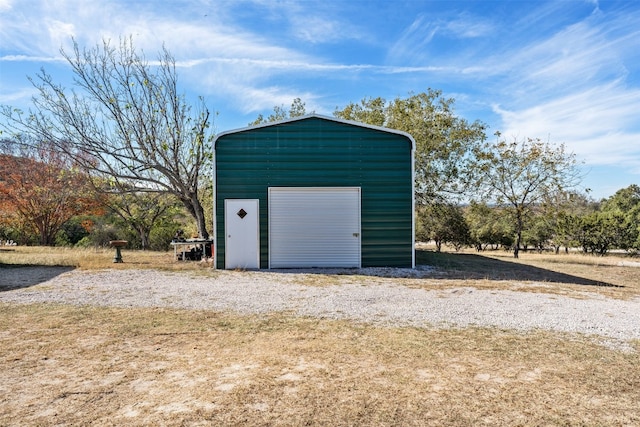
[{"xmin": 214, "ymin": 114, "xmax": 415, "ymax": 269}]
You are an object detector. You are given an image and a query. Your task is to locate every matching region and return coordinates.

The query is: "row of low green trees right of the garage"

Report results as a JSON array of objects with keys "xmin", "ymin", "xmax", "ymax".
[{"xmin": 416, "ymin": 185, "xmax": 640, "ymax": 255}]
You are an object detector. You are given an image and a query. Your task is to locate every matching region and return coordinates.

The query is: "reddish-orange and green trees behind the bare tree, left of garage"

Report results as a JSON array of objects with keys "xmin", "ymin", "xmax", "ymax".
[{"xmin": 0, "ymin": 139, "xmax": 199, "ymax": 250}]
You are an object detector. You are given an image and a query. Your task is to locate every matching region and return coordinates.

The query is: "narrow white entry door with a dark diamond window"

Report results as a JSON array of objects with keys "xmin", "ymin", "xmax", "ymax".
[{"xmin": 224, "ymin": 199, "xmax": 260, "ymax": 269}]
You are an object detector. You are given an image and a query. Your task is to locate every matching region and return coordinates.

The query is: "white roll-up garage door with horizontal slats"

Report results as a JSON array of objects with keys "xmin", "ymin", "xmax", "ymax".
[{"xmin": 268, "ymin": 187, "xmax": 361, "ymax": 268}]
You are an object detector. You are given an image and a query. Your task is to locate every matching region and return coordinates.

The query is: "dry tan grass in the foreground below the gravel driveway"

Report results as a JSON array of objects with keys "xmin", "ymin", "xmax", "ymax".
[{"xmin": 0, "ymin": 305, "xmax": 640, "ymax": 426}]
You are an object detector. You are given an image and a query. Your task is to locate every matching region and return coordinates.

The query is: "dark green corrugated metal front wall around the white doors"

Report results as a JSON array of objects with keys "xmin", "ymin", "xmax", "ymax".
[{"xmin": 215, "ymin": 117, "xmax": 413, "ymax": 268}]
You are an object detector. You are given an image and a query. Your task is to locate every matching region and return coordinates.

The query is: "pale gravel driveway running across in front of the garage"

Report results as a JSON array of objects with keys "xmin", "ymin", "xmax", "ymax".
[{"xmin": 0, "ymin": 267, "xmax": 640, "ymax": 347}]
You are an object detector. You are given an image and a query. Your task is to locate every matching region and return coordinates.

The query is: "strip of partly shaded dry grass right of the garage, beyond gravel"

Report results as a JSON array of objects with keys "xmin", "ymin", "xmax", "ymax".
[{"xmin": 411, "ymin": 249, "xmax": 640, "ymax": 299}]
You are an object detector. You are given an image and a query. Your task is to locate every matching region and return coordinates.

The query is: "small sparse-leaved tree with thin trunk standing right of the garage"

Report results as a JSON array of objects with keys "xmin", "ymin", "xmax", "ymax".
[{"xmin": 474, "ymin": 133, "xmax": 579, "ymax": 258}]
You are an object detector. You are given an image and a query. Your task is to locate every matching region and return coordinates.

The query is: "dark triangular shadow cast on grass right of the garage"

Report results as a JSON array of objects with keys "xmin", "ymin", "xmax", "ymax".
[{"xmin": 416, "ymin": 250, "xmax": 624, "ymax": 288}]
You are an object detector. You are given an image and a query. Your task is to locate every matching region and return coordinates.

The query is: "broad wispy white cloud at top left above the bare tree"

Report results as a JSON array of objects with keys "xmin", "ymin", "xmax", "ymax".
[{"xmin": 0, "ymin": 0, "xmax": 305, "ymax": 59}]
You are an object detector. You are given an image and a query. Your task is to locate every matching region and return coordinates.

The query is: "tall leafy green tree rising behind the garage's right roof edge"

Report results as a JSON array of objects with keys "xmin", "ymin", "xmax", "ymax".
[{"xmin": 333, "ymin": 89, "xmax": 486, "ymax": 205}]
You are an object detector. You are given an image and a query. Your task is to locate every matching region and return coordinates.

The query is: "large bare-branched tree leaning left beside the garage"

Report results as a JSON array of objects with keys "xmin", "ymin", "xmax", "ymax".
[{"xmin": 1, "ymin": 38, "xmax": 212, "ymax": 238}]
